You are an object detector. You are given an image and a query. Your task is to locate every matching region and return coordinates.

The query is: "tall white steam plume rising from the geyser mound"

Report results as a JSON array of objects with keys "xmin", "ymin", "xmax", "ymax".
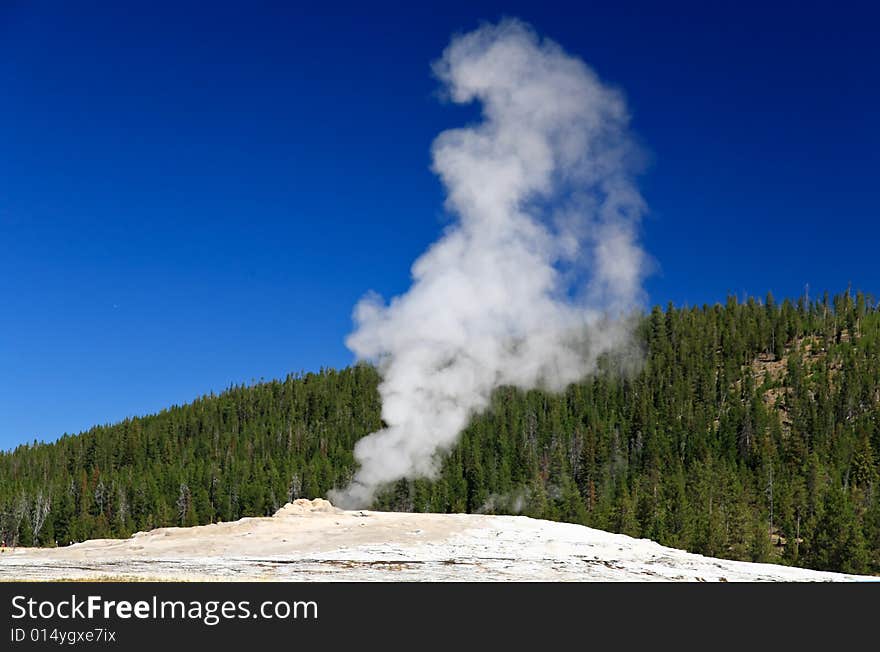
[{"xmin": 331, "ymin": 20, "xmax": 645, "ymax": 508}]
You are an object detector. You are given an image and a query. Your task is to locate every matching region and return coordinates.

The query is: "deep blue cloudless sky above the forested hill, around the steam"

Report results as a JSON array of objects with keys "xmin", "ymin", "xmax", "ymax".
[{"xmin": 0, "ymin": 0, "xmax": 880, "ymax": 448}]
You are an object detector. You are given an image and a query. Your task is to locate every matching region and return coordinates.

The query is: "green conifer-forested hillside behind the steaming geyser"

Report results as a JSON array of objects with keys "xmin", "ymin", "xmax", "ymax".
[{"xmin": 0, "ymin": 292, "xmax": 880, "ymax": 573}]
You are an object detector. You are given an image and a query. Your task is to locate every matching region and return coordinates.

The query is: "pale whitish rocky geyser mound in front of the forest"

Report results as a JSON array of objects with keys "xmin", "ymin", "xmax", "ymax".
[{"xmin": 0, "ymin": 499, "xmax": 880, "ymax": 582}]
